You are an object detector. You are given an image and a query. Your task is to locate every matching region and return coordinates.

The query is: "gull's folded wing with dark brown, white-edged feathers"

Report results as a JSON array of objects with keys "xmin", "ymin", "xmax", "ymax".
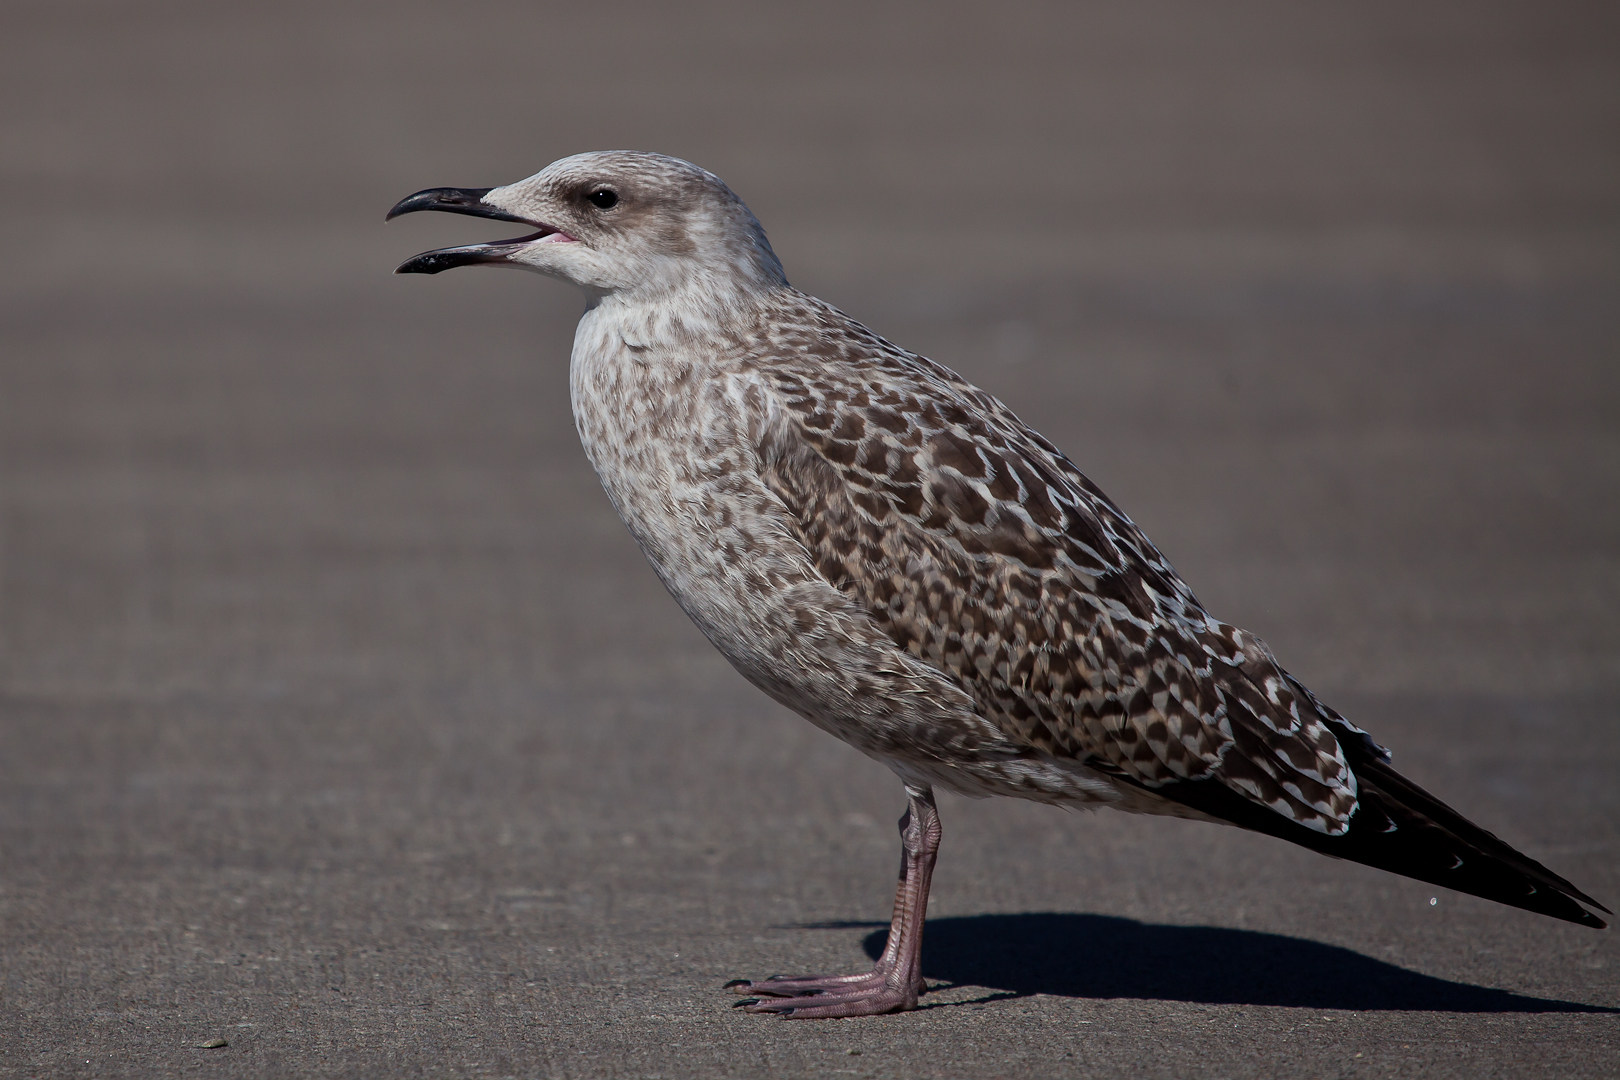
[{"xmin": 757, "ymin": 299, "xmax": 1356, "ymax": 836}]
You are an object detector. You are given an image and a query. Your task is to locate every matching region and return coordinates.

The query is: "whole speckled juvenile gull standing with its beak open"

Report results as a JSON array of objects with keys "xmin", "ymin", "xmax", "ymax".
[{"xmin": 389, "ymin": 152, "xmax": 1609, "ymax": 1017}]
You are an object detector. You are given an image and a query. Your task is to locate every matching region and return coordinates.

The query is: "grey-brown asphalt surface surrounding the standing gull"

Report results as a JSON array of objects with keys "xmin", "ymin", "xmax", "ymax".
[{"xmin": 0, "ymin": 2, "xmax": 1620, "ymax": 1078}]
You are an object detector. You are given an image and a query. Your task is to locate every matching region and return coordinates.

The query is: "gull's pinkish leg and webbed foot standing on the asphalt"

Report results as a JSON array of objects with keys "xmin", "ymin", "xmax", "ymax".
[{"xmin": 726, "ymin": 784, "xmax": 940, "ymax": 1020}]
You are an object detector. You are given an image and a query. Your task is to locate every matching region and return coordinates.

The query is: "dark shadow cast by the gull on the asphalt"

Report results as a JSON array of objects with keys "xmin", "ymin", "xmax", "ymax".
[{"xmin": 793, "ymin": 913, "xmax": 1620, "ymax": 1012}]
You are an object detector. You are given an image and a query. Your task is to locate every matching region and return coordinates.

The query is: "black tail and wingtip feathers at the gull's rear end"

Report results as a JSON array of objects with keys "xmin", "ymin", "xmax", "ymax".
[{"xmin": 1152, "ymin": 738, "xmax": 1614, "ymax": 929}]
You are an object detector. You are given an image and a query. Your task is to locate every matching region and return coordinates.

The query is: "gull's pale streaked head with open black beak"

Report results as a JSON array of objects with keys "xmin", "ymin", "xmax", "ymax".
[{"xmin": 389, "ymin": 151, "xmax": 786, "ymax": 298}]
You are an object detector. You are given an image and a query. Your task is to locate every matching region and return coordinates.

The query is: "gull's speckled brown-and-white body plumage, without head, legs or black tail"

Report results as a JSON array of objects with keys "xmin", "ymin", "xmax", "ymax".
[{"xmin": 572, "ymin": 285, "xmax": 1364, "ymax": 836}]
